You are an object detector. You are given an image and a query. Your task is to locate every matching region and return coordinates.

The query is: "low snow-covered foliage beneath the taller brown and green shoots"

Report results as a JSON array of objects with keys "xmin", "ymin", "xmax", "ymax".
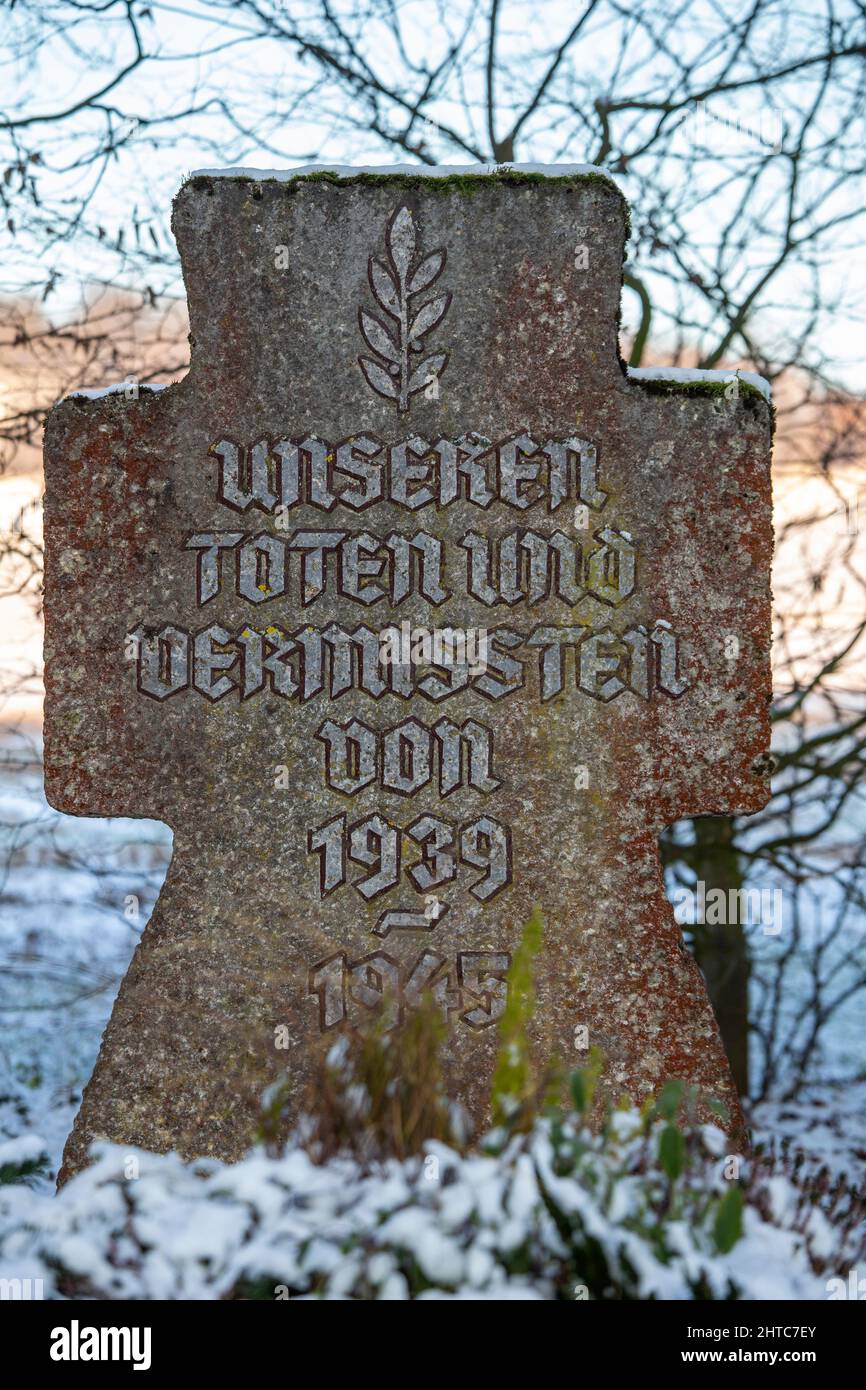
[{"xmin": 0, "ymin": 1086, "xmax": 852, "ymax": 1300}]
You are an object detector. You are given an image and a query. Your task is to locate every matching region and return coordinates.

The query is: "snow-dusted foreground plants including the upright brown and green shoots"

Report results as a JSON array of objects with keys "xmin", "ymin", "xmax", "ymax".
[{"xmin": 0, "ymin": 920, "xmax": 863, "ymax": 1300}]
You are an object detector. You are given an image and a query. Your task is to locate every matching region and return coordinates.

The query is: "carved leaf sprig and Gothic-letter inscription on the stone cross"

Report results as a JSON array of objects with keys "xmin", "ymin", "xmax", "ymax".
[{"xmin": 129, "ymin": 222, "xmax": 697, "ymax": 1031}]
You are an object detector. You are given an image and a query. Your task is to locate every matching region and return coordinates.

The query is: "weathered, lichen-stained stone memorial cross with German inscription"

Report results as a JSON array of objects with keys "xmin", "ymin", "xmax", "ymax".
[{"xmin": 44, "ymin": 165, "xmax": 771, "ymax": 1175}]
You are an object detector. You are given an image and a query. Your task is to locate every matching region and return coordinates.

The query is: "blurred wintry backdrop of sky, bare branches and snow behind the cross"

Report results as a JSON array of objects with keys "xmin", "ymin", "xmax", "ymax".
[{"xmin": 0, "ymin": 0, "xmax": 866, "ymax": 1177}]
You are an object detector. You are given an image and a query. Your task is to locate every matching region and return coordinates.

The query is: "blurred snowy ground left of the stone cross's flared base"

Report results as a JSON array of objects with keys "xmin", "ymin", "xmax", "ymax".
[{"xmin": 0, "ymin": 735, "xmax": 171, "ymax": 1163}]
